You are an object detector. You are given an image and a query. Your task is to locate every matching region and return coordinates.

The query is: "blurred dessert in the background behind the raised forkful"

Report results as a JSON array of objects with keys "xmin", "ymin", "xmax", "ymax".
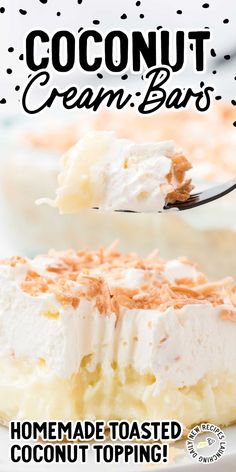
[{"xmin": 0, "ymin": 105, "xmax": 236, "ymax": 277}]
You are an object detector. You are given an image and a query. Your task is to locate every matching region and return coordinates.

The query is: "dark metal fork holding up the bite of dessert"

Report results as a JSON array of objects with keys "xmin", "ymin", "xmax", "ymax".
[{"xmin": 96, "ymin": 177, "xmax": 236, "ymax": 213}]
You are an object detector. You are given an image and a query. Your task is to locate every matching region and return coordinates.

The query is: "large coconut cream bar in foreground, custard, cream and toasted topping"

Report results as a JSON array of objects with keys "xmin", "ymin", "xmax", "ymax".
[{"xmin": 0, "ymin": 246, "xmax": 236, "ymax": 427}]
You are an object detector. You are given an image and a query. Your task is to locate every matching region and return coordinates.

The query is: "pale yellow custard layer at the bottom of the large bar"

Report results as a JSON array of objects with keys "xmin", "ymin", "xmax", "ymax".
[{"xmin": 0, "ymin": 356, "xmax": 236, "ymax": 427}]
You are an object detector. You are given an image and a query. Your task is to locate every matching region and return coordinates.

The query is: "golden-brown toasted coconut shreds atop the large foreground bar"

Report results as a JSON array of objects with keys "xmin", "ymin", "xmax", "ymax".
[{"xmin": 2, "ymin": 245, "xmax": 236, "ymax": 319}]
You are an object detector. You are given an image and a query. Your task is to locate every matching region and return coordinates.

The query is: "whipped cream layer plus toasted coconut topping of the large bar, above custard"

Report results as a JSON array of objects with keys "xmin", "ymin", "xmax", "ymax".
[{"xmin": 0, "ymin": 247, "xmax": 236, "ymax": 391}]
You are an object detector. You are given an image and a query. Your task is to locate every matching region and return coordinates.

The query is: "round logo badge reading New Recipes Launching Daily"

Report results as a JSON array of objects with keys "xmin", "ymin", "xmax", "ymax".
[{"xmin": 186, "ymin": 423, "xmax": 226, "ymax": 464}]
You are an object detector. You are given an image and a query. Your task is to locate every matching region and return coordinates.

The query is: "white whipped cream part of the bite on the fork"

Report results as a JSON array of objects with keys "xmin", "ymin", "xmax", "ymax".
[{"xmin": 93, "ymin": 138, "xmax": 175, "ymax": 212}]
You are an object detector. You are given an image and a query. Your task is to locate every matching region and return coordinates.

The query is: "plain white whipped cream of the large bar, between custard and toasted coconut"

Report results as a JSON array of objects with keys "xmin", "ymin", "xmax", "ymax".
[{"xmin": 0, "ymin": 261, "xmax": 236, "ymax": 388}]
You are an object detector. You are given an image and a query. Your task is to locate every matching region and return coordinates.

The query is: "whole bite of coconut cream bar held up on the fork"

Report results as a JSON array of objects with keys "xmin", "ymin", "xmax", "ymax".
[{"xmin": 41, "ymin": 131, "xmax": 192, "ymax": 213}]
